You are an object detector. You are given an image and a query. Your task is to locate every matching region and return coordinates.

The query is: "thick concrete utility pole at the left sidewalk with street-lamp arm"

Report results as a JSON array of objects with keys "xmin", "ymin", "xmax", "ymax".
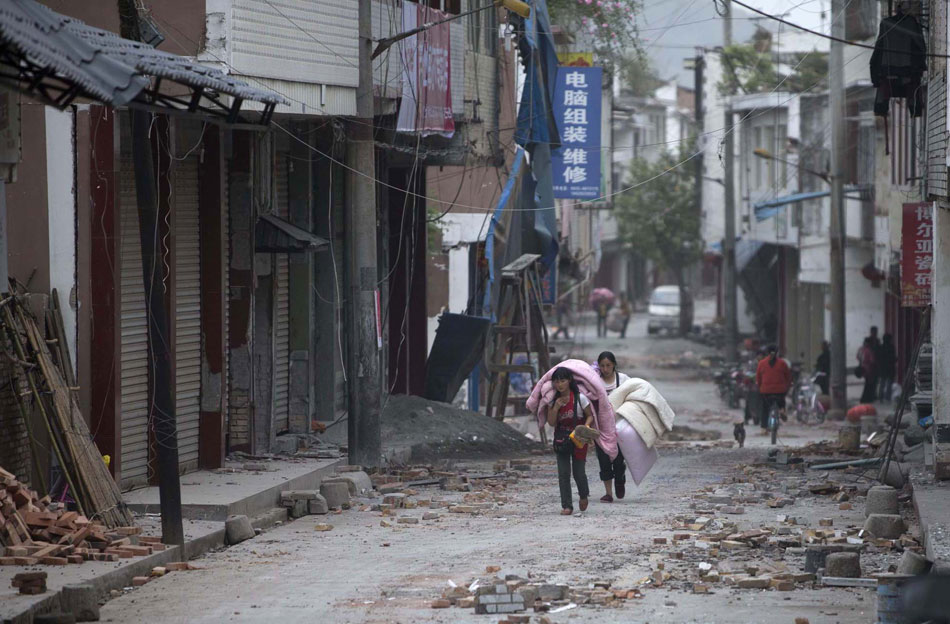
[{"xmin": 346, "ymin": 0, "xmax": 382, "ymax": 467}]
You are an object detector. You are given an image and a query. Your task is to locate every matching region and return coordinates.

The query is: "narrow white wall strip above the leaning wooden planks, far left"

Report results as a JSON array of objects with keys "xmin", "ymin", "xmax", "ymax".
[{"xmin": 46, "ymin": 106, "xmax": 77, "ymax": 370}]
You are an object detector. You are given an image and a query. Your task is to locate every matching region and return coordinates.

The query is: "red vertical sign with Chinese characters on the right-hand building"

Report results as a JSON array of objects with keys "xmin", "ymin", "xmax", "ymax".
[{"xmin": 901, "ymin": 202, "xmax": 934, "ymax": 308}]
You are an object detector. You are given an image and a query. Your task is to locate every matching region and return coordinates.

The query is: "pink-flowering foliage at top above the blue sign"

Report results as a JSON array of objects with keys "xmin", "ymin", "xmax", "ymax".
[{"xmin": 548, "ymin": 0, "xmax": 640, "ymax": 59}]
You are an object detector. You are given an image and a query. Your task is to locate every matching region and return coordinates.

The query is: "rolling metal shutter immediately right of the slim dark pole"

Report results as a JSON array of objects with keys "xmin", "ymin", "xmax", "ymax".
[{"xmin": 172, "ymin": 156, "xmax": 201, "ymax": 471}]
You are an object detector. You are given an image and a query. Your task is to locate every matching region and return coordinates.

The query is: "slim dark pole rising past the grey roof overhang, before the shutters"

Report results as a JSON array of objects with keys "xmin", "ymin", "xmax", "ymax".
[{"xmin": 118, "ymin": 0, "xmax": 185, "ymax": 546}]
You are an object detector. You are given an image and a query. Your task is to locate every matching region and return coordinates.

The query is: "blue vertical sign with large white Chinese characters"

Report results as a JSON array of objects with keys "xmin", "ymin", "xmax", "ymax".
[{"xmin": 551, "ymin": 67, "xmax": 602, "ymax": 199}]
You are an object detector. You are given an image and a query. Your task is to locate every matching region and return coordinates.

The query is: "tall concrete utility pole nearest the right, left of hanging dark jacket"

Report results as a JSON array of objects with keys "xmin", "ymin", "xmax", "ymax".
[{"xmin": 828, "ymin": 0, "xmax": 848, "ymax": 418}]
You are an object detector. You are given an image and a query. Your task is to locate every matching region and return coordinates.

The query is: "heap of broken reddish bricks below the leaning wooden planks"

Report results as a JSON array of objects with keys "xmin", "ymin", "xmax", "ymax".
[{"xmin": 0, "ymin": 468, "xmax": 165, "ymax": 565}]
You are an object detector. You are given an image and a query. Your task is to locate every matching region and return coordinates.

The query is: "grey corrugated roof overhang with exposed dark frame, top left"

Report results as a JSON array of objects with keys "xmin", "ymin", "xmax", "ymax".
[{"xmin": 0, "ymin": 0, "xmax": 286, "ymax": 124}]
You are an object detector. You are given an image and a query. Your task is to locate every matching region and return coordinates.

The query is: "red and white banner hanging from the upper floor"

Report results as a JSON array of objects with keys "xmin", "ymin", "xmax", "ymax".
[{"xmin": 396, "ymin": 2, "xmax": 455, "ymax": 138}]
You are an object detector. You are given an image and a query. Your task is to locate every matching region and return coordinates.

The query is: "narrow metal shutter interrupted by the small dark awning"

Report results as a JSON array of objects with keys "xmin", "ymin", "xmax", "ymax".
[{"xmin": 274, "ymin": 152, "xmax": 290, "ymax": 433}]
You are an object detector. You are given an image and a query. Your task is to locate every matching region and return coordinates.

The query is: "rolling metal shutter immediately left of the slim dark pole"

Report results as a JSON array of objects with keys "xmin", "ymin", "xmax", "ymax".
[{"xmin": 119, "ymin": 155, "xmax": 149, "ymax": 489}]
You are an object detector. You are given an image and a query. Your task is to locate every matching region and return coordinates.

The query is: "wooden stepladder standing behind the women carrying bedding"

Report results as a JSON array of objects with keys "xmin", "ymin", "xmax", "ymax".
[{"xmin": 485, "ymin": 254, "xmax": 551, "ymax": 442}]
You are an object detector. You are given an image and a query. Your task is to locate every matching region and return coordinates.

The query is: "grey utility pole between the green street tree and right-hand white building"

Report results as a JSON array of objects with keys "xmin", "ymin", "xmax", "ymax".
[{"xmin": 721, "ymin": 0, "xmax": 739, "ymax": 362}]
